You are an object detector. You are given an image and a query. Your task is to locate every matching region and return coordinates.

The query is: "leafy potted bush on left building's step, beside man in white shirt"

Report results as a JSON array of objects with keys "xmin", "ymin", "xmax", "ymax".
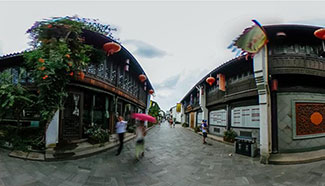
[{"xmin": 85, "ymin": 124, "xmax": 109, "ymax": 144}]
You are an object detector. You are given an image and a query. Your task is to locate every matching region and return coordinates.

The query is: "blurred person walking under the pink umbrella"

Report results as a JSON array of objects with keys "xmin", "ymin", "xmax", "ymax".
[{"xmin": 135, "ymin": 121, "xmax": 146, "ymax": 160}]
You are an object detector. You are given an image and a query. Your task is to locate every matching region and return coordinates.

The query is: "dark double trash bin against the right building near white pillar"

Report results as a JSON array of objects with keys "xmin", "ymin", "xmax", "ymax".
[{"xmin": 235, "ymin": 136, "xmax": 257, "ymax": 157}]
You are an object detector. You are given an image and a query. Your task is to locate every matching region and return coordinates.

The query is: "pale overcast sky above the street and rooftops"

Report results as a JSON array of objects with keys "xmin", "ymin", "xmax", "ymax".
[{"xmin": 0, "ymin": 0, "xmax": 325, "ymax": 110}]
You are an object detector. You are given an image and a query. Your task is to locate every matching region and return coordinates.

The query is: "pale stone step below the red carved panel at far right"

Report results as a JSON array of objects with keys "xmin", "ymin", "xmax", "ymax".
[{"xmin": 269, "ymin": 149, "xmax": 325, "ymax": 165}]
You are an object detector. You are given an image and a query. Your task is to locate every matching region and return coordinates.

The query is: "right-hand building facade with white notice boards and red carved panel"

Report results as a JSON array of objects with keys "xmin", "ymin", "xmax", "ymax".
[{"xmin": 181, "ymin": 25, "xmax": 325, "ymax": 161}]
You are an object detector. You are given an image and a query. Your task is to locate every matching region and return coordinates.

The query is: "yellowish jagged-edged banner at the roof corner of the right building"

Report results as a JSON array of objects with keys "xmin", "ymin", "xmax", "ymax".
[{"xmin": 227, "ymin": 19, "xmax": 268, "ymax": 60}]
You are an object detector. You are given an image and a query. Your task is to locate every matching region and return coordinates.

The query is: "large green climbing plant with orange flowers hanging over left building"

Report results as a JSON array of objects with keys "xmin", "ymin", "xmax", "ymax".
[{"xmin": 24, "ymin": 17, "xmax": 114, "ymax": 130}]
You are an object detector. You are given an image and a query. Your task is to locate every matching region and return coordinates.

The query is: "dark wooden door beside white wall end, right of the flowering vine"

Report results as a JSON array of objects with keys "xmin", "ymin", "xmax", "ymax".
[{"xmin": 60, "ymin": 92, "xmax": 83, "ymax": 141}]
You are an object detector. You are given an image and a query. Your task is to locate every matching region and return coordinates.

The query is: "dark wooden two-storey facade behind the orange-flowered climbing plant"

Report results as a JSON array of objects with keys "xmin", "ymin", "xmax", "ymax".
[{"xmin": 0, "ymin": 30, "xmax": 153, "ymax": 146}]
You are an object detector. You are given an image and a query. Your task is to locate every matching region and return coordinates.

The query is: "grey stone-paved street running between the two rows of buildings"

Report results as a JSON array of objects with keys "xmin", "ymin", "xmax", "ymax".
[{"xmin": 0, "ymin": 123, "xmax": 325, "ymax": 186}]
